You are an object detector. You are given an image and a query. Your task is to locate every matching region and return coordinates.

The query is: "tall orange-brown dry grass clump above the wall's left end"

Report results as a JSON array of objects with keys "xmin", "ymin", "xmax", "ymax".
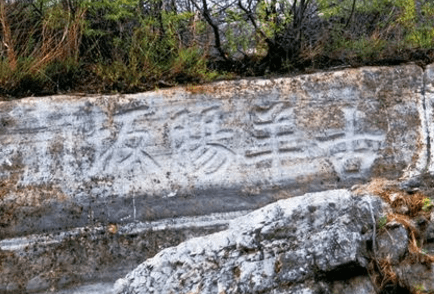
[{"xmin": 0, "ymin": 0, "xmax": 87, "ymax": 96}]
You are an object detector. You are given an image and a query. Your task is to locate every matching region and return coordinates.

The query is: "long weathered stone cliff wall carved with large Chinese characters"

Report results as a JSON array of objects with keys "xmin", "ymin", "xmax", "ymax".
[{"xmin": 0, "ymin": 65, "xmax": 434, "ymax": 292}]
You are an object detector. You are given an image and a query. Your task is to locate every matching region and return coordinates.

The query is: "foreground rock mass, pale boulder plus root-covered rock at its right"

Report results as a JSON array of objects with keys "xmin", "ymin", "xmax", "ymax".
[{"xmin": 113, "ymin": 189, "xmax": 434, "ymax": 294}]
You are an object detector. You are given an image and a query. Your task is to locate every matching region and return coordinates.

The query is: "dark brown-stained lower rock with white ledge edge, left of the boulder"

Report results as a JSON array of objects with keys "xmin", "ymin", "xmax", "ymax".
[{"xmin": 0, "ymin": 212, "xmax": 247, "ymax": 294}]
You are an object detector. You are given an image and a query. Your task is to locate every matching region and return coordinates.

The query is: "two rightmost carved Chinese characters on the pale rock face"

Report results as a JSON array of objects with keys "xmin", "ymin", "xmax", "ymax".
[{"xmin": 245, "ymin": 103, "xmax": 385, "ymax": 178}]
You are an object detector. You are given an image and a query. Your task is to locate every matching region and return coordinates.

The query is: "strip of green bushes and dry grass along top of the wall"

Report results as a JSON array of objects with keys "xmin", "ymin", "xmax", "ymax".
[{"xmin": 0, "ymin": 0, "xmax": 434, "ymax": 99}]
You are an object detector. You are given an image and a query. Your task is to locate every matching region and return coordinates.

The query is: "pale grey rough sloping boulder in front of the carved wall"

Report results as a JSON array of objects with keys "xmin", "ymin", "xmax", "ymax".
[{"xmin": 116, "ymin": 190, "xmax": 382, "ymax": 294}]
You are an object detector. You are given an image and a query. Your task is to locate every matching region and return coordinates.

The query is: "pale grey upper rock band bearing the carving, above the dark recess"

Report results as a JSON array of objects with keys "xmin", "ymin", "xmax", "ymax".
[{"xmin": 0, "ymin": 63, "xmax": 419, "ymax": 196}]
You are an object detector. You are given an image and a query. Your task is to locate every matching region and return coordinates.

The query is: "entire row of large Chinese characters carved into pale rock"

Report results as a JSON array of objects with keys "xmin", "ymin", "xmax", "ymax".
[{"xmin": 1, "ymin": 102, "xmax": 385, "ymax": 191}]
